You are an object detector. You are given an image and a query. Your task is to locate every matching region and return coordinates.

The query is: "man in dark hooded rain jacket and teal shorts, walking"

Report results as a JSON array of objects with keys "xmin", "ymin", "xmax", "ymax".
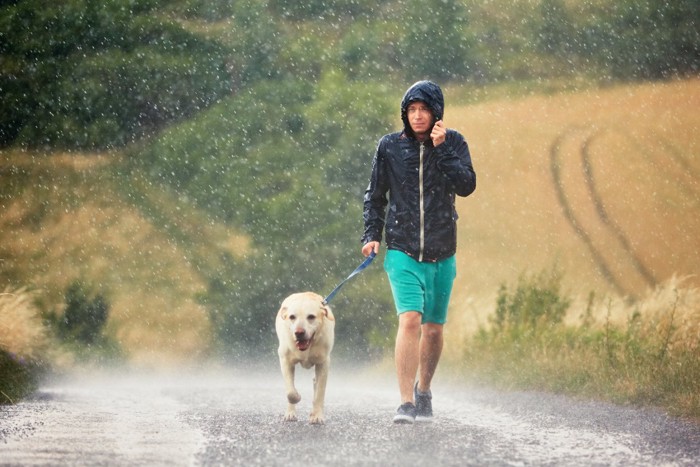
[{"xmin": 362, "ymin": 81, "xmax": 476, "ymax": 423}]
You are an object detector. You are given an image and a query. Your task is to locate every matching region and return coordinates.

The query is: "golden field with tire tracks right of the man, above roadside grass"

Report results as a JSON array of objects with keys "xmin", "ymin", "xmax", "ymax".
[{"xmin": 445, "ymin": 79, "xmax": 700, "ymax": 325}]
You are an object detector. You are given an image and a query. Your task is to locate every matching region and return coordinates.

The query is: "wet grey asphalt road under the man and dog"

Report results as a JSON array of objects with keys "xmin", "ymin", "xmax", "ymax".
[{"xmin": 0, "ymin": 367, "xmax": 700, "ymax": 467}]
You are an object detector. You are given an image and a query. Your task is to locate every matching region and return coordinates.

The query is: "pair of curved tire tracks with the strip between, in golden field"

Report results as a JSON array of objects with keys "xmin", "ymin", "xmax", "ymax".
[{"xmin": 550, "ymin": 127, "xmax": 658, "ymax": 298}]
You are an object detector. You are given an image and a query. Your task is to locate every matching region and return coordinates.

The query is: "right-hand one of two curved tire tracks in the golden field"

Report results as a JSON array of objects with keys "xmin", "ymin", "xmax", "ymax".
[{"xmin": 581, "ymin": 131, "xmax": 659, "ymax": 287}]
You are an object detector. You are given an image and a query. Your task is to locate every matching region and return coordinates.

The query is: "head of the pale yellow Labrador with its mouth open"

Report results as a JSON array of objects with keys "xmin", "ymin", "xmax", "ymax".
[{"xmin": 278, "ymin": 292, "xmax": 333, "ymax": 351}]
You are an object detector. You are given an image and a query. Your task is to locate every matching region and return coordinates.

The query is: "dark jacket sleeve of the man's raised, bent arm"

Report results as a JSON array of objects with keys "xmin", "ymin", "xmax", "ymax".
[{"xmin": 435, "ymin": 130, "xmax": 476, "ymax": 196}]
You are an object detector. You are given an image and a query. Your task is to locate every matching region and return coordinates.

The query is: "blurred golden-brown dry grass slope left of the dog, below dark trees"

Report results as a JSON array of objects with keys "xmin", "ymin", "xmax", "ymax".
[{"xmin": 0, "ymin": 152, "xmax": 247, "ymax": 365}]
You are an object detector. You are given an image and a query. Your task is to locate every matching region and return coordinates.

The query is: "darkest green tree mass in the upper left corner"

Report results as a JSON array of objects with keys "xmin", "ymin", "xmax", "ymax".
[{"xmin": 0, "ymin": 0, "xmax": 231, "ymax": 148}]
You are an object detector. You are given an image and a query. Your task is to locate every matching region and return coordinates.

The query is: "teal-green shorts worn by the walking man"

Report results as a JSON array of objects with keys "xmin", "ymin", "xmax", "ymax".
[{"xmin": 384, "ymin": 250, "xmax": 457, "ymax": 324}]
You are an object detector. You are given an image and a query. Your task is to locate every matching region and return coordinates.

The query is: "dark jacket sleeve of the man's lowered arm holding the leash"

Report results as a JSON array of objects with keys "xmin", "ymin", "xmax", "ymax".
[{"xmin": 361, "ymin": 140, "xmax": 389, "ymax": 245}]
